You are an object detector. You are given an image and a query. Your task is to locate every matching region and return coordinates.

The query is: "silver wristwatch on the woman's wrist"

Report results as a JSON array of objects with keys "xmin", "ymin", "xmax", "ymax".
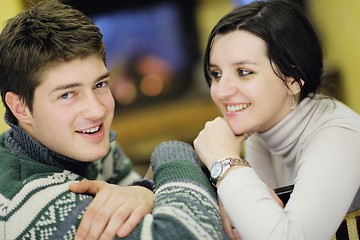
[{"xmin": 210, "ymin": 158, "xmax": 250, "ymax": 186}]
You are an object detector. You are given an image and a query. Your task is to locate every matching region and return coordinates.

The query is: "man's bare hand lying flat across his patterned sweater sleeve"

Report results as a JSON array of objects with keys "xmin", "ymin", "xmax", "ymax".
[{"xmin": 69, "ymin": 180, "xmax": 154, "ymax": 239}]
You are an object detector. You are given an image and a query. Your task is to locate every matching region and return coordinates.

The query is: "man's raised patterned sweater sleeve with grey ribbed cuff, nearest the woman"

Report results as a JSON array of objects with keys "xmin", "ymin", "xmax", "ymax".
[{"xmin": 71, "ymin": 142, "xmax": 224, "ymax": 239}]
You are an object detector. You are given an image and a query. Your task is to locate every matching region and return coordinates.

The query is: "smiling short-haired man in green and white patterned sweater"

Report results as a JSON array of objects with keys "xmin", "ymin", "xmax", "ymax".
[{"xmin": 0, "ymin": 1, "xmax": 223, "ymax": 239}]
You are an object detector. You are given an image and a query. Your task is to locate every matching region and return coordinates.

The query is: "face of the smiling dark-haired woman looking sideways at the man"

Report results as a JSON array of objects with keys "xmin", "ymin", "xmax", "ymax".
[{"xmin": 209, "ymin": 30, "xmax": 295, "ymax": 135}]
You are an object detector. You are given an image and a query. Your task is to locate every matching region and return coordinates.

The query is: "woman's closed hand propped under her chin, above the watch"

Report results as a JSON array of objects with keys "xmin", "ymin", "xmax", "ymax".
[{"xmin": 194, "ymin": 117, "xmax": 246, "ymax": 169}]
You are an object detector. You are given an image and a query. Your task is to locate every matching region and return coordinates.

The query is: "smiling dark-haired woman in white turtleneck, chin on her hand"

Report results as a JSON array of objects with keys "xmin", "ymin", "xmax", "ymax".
[{"xmin": 194, "ymin": 0, "xmax": 360, "ymax": 240}]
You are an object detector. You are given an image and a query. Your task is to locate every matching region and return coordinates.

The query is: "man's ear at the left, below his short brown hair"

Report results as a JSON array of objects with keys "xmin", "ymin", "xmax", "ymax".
[{"xmin": 5, "ymin": 92, "xmax": 31, "ymax": 123}]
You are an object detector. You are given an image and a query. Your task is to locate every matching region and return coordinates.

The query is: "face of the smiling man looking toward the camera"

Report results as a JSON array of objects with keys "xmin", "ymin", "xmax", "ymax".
[{"xmin": 21, "ymin": 56, "xmax": 115, "ymax": 162}]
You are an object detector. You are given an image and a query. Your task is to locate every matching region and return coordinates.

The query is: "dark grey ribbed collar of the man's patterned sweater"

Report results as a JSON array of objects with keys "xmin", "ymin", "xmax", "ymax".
[{"xmin": 4, "ymin": 112, "xmax": 116, "ymax": 178}]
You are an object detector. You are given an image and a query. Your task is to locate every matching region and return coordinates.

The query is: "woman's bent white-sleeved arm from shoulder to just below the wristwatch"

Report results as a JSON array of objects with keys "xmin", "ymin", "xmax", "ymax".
[{"xmin": 218, "ymin": 128, "xmax": 360, "ymax": 239}]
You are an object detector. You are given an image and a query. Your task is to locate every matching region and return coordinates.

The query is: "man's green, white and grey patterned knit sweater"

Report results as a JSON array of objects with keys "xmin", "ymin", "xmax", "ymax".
[{"xmin": 0, "ymin": 126, "xmax": 226, "ymax": 240}]
